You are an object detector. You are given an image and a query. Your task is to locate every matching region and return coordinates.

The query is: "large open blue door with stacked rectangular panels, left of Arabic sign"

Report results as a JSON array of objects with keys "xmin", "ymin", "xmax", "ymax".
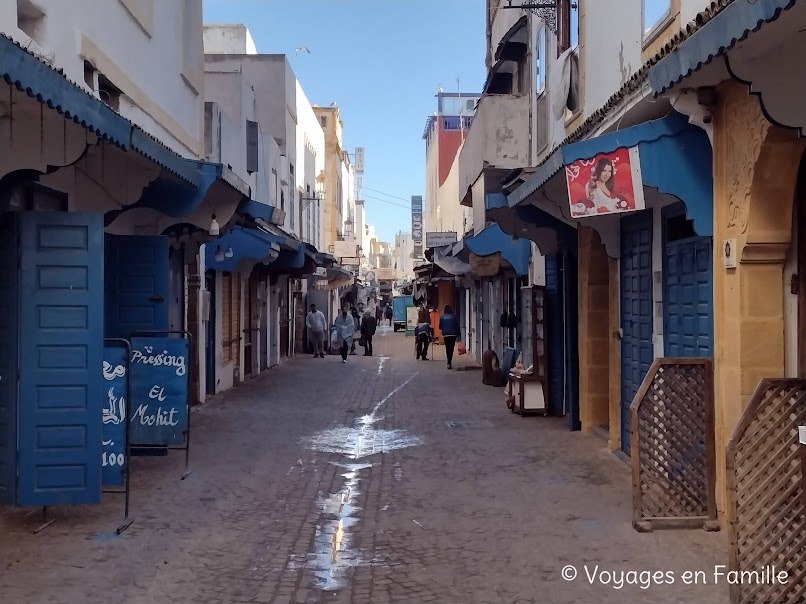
[{"xmin": 17, "ymin": 212, "xmax": 104, "ymax": 505}]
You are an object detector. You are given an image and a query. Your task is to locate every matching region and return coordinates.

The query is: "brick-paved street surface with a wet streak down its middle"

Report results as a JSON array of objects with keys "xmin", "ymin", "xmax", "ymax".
[{"xmin": 0, "ymin": 331, "xmax": 728, "ymax": 604}]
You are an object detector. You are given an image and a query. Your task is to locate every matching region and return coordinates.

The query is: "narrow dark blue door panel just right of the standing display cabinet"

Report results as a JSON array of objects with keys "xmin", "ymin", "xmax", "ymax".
[{"xmin": 546, "ymin": 254, "xmax": 565, "ymax": 417}]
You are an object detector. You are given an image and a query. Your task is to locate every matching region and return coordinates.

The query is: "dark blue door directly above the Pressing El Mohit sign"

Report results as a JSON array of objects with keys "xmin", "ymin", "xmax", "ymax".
[{"xmin": 105, "ymin": 235, "xmax": 170, "ymax": 339}]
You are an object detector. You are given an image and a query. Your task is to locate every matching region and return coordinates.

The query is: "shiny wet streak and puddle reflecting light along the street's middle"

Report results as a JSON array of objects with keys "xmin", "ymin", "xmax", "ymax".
[{"xmin": 302, "ymin": 374, "xmax": 422, "ymax": 591}]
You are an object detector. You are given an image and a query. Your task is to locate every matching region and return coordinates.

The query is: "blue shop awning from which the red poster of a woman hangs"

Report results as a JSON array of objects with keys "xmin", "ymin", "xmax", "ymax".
[{"xmin": 508, "ymin": 113, "xmax": 713, "ymax": 258}]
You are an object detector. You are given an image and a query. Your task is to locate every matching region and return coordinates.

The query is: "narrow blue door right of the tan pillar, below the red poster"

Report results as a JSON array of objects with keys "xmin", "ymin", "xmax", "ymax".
[{"xmin": 620, "ymin": 210, "xmax": 654, "ymax": 455}]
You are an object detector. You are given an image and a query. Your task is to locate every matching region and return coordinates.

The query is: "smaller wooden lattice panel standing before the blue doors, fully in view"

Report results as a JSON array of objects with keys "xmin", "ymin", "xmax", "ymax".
[{"xmin": 630, "ymin": 358, "xmax": 717, "ymax": 531}]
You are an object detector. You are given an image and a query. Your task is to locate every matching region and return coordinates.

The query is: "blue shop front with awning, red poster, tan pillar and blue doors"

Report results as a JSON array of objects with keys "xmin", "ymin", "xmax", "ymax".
[{"xmin": 504, "ymin": 113, "xmax": 713, "ymax": 448}]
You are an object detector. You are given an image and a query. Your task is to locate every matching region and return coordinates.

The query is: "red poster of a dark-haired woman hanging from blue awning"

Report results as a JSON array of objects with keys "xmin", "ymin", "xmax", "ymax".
[{"xmin": 565, "ymin": 147, "xmax": 646, "ymax": 218}]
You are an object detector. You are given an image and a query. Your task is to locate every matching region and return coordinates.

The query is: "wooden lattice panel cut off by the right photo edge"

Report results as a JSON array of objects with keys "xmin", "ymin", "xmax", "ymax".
[{"xmin": 727, "ymin": 379, "xmax": 806, "ymax": 604}]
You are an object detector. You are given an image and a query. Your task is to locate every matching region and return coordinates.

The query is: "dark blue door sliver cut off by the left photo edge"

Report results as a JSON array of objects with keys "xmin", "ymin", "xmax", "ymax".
[{"xmin": 0, "ymin": 214, "xmax": 19, "ymax": 505}]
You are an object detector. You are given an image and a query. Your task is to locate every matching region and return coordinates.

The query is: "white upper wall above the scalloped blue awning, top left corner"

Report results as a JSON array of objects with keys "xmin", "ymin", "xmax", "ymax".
[{"xmin": 0, "ymin": 0, "xmax": 204, "ymax": 157}]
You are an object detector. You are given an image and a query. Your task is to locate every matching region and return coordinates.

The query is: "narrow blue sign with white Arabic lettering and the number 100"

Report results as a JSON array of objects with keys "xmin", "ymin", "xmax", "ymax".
[{"xmin": 101, "ymin": 346, "xmax": 129, "ymax": 487}]
